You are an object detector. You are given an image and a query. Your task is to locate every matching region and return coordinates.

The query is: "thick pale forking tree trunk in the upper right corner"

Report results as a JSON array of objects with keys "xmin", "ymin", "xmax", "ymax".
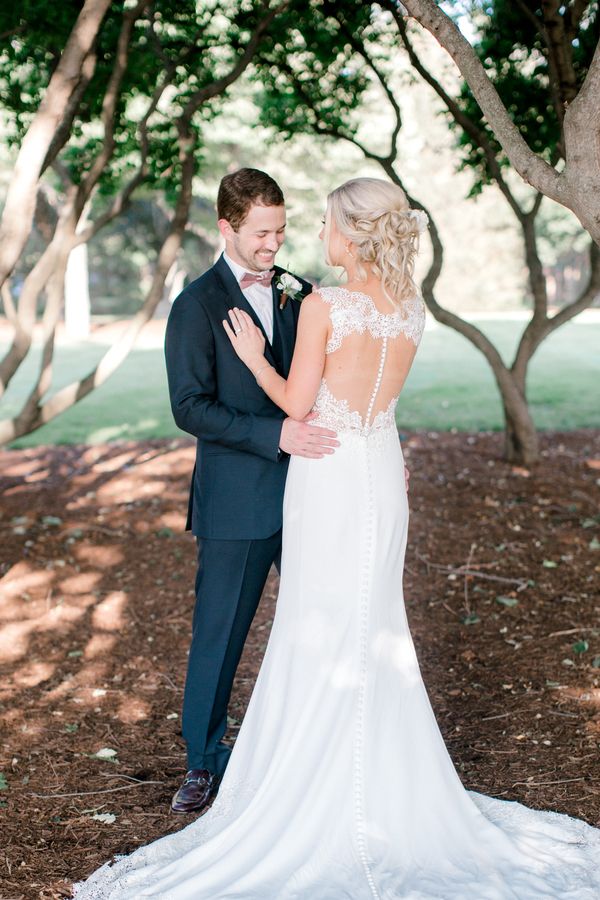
[{"xmin": 398, "ymin": 0, "xmax": 600, "ymax": 245}]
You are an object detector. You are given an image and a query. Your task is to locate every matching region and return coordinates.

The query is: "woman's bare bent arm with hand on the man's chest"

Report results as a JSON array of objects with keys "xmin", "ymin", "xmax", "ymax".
[{"xmin": 223, "ymin": 294, "xmax": 329, "ymax": 420}]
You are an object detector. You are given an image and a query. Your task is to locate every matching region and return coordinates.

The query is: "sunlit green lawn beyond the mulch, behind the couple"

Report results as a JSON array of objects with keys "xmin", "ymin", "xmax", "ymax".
[{"xmin": 0, "ymin": 319, "xmax": 600, "ymax": 447}]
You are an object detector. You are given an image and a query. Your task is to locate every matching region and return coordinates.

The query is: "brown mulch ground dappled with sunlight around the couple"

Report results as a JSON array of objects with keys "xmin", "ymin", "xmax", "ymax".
[{"xmin": 0, "ymin": 431, "xmax": 600, "ymax": 900}]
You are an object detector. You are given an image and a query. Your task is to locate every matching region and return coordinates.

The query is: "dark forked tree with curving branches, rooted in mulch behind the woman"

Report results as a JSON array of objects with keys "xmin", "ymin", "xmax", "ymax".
[{"xmin": 251, "ymin": 2, "xmax": 600, "ymax": 464}]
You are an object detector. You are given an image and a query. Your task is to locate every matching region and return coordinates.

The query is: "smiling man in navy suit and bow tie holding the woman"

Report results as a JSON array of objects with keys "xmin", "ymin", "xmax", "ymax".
[{"xmin": 165, "ymin": 168, "xmax": 337, "ymax": 813}]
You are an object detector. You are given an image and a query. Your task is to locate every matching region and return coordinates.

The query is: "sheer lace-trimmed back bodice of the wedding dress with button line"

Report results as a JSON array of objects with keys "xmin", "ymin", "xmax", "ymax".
[{"xmin": 313, "ymin": 287, "xmax": 425, "ymax": 435}]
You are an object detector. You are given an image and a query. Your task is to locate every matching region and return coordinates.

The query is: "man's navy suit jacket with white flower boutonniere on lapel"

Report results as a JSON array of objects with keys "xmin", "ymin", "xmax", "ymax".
[{"xmin": 165, "ymin": 256, "xmax": 312, "ymax": 540}]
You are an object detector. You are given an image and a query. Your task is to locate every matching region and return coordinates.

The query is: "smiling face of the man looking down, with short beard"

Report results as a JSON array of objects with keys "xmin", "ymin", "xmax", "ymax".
[{"xmin": 219, "ymin": 204, "xmax": 286, "ymax": 272}]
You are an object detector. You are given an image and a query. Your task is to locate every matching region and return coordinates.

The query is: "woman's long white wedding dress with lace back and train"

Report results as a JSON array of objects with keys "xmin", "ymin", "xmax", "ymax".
[{"xmin": 75, "ymin": 288, "xmax": 600, "ymax": 900}]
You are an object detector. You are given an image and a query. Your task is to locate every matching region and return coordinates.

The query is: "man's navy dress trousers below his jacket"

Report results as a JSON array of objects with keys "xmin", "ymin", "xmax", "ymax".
[{"xmin": 182, "ymin": 529, "xmax": 281, "ymax": 776}]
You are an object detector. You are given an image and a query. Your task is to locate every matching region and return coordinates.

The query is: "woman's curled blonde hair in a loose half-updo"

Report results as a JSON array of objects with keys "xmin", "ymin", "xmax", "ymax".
[{"xmin": 324, "ymin": 178, "xmax": 424, "ymax": 307}]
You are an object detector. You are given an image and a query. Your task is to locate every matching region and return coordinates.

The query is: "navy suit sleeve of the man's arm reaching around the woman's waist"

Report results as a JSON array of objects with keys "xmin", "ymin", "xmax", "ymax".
[{"xmin": 165, "ymin": 294, "xmax": 283, "ymax": 462}]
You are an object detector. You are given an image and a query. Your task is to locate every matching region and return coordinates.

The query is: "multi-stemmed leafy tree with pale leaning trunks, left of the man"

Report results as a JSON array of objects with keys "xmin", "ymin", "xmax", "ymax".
[{"xmin": 0, "ymin": 0, "xmax": 286, "ymax": 443}]
